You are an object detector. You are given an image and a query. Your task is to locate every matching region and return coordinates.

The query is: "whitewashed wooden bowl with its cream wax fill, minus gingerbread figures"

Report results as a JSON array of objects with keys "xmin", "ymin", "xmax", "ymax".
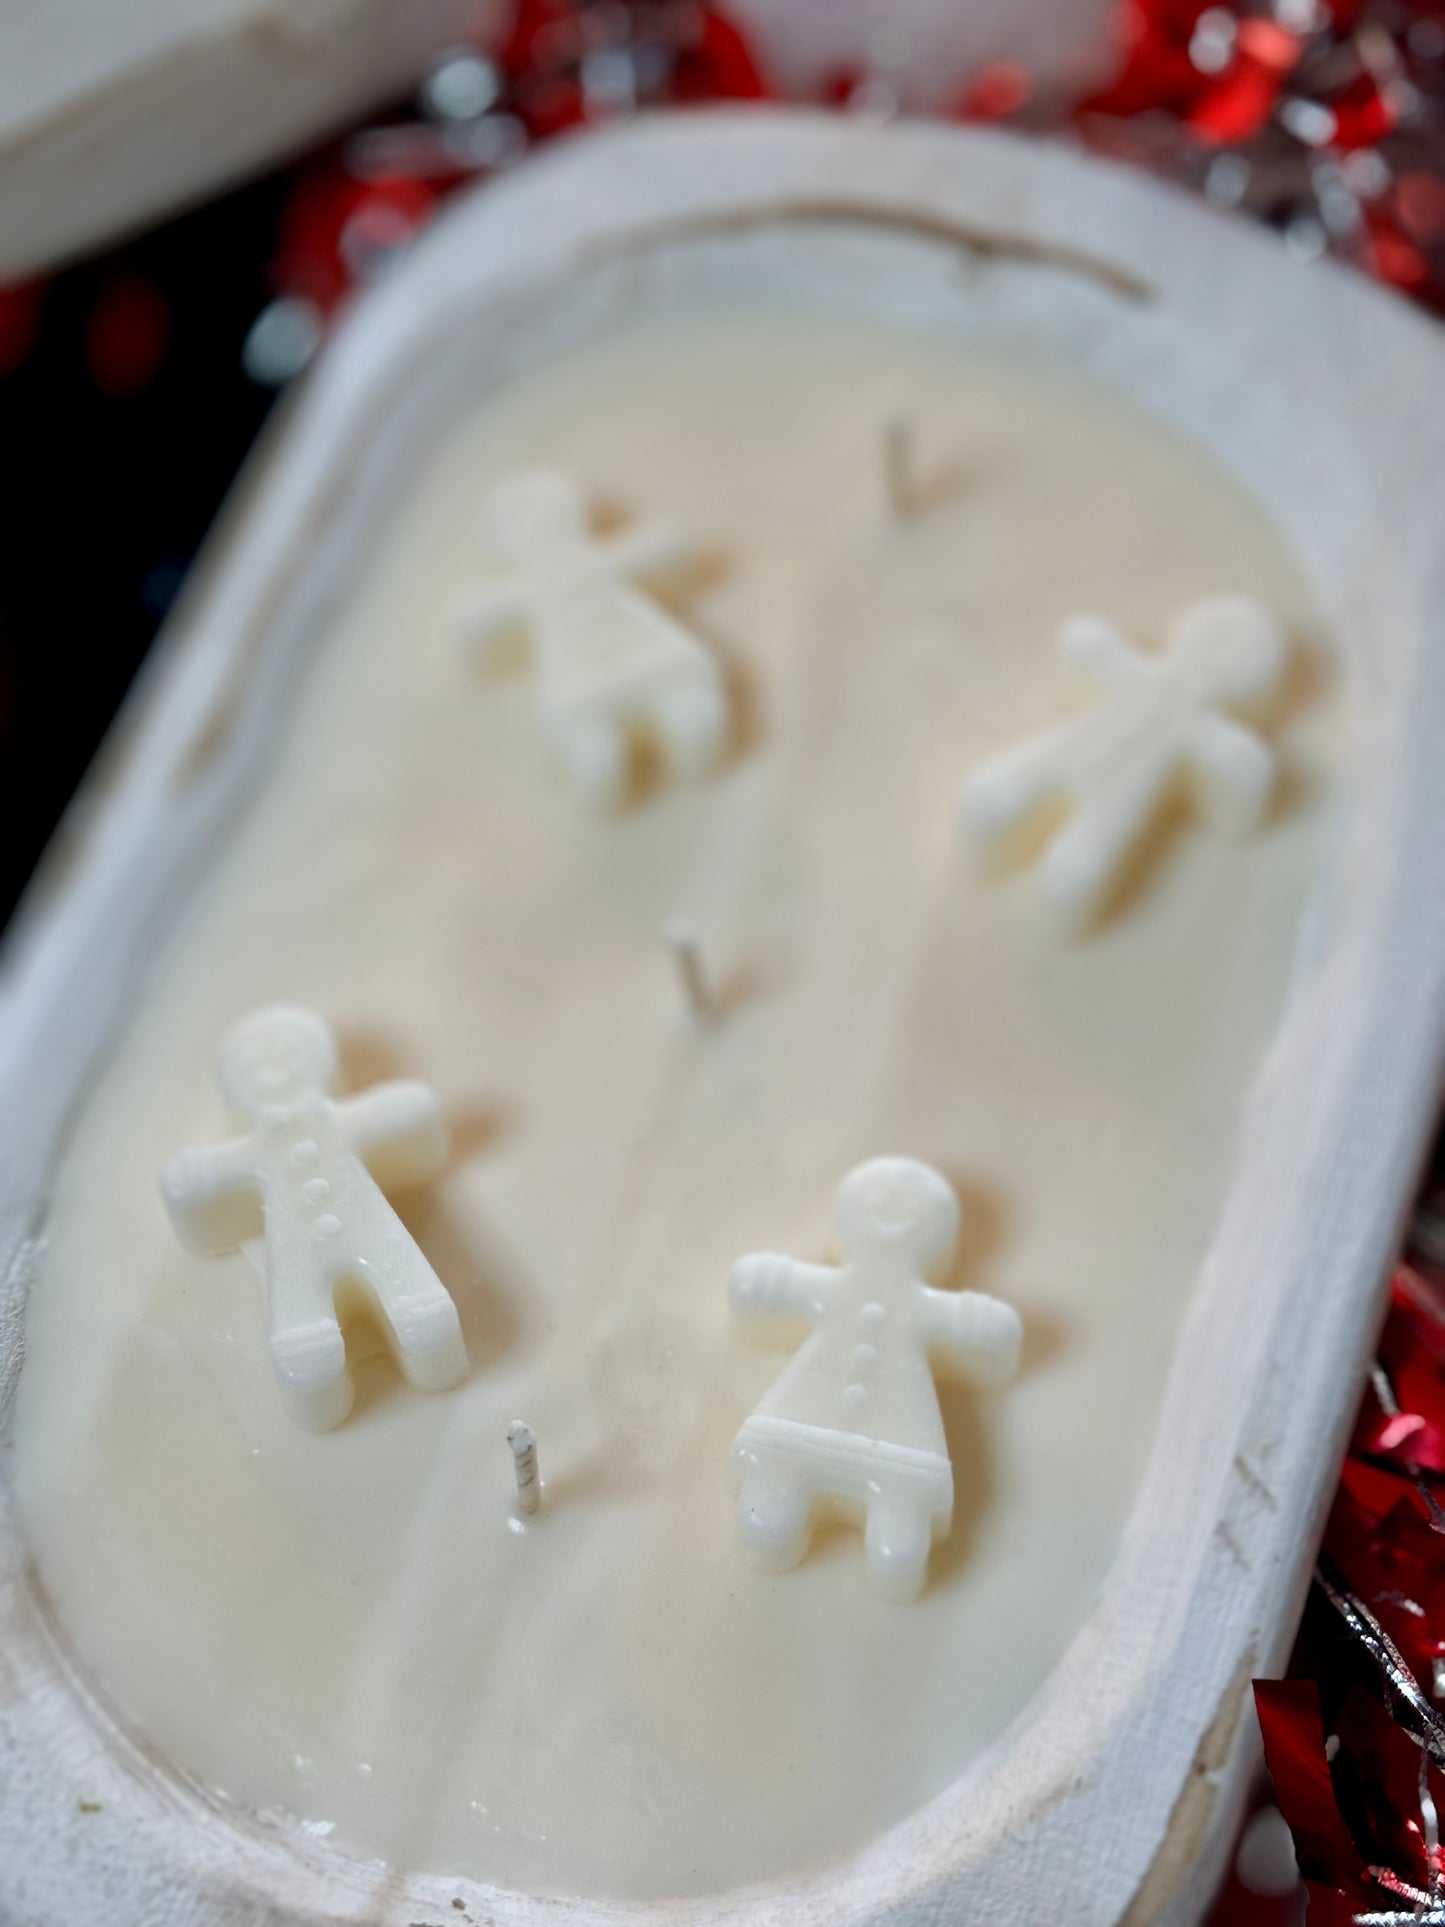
[{"xmin": 0, "ymin": 116, "xmax": 1445, "ymax": 1923}]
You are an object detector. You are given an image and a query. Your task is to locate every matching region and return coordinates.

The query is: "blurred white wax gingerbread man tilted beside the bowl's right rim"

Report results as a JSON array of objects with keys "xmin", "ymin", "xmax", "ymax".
[{"xmin": 959, "ymin": 595, "xmax": 1287, "ymax": 935}]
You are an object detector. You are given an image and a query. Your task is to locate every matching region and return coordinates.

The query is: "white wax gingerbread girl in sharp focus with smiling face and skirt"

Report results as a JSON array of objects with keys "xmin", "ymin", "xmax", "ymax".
[{"xmin": 728, "ymin": 1158, "xmax": 1021, "ymax": 1601}]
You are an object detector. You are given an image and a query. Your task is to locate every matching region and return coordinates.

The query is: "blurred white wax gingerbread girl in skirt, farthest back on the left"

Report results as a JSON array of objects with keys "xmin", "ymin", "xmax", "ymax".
[{"xmin": 459, "ymin": 472, "xmax": 728, "ymax": 809}]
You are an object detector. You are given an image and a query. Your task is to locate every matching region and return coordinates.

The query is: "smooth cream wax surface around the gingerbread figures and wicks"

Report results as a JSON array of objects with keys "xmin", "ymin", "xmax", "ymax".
[{"xmin": 17, "ymin": 314, "xmax": 1333, "ymax": 1896}]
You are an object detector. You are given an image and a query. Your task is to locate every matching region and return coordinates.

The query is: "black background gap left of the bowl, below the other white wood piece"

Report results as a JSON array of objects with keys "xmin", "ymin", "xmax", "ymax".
[{"xmin": 0, "ymin": 175, "xmax": 287, "ymax": 923}]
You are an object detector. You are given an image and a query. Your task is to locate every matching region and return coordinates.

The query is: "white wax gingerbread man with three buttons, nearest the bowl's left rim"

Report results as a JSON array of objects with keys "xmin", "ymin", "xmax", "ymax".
[{"xmin": 160, "ymin": 1006, "xmax": 466, "ymax": 1432}]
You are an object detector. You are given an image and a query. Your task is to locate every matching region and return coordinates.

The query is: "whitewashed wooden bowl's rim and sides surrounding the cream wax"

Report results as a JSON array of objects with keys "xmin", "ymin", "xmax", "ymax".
[{"xmin": 0, "ymin": 114, "xmax": 1445, "ymax": 1927}]
